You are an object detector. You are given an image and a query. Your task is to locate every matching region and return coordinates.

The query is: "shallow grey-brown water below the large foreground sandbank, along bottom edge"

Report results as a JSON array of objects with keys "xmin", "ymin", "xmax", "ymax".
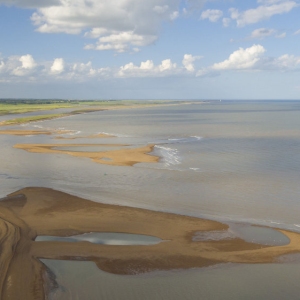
[{"xmin": 42, "ymin": 260, "xmax": 300, "ymax": 300}]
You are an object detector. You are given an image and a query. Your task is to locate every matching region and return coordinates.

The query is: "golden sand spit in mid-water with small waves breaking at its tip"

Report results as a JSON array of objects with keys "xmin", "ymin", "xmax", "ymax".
[{"xmin": 14, "ymin": 144, "xmax": 159, "ymax": 166}]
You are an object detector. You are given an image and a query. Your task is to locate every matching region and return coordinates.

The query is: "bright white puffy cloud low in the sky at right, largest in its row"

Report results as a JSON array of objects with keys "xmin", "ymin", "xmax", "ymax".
[{"xmin": 212, "ymin": 45, "xmax": 266, "ymax": 70}]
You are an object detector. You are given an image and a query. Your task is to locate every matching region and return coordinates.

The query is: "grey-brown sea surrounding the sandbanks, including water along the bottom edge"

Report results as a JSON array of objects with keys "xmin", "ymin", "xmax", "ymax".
[{"xmin": 0, "ymin": 100, "xmax": 300, "ymax": 300}]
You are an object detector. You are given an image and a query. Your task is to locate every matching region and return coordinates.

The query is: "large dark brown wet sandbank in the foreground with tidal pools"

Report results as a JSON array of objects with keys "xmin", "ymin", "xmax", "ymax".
[{"xmin": 0, "ymin": 188, "xmax": 300, "ymax": 300}]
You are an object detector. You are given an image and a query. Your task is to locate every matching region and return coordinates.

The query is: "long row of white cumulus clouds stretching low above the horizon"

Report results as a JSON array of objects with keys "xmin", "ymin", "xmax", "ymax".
[{"xmin": 0, "ymin": 50, "xmax": 300, "ymax": 83}]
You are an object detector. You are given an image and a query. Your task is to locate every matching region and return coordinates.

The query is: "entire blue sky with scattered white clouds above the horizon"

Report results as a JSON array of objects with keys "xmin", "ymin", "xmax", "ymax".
[{"xmin": 0, "ymin": 0, "xmax": 300, "ymax": 100}]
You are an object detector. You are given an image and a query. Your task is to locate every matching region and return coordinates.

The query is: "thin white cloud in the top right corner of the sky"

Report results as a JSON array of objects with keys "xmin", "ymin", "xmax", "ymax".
[{"xmin": 229, "ymin": 0, "xmax": 298, "ymax": 27}]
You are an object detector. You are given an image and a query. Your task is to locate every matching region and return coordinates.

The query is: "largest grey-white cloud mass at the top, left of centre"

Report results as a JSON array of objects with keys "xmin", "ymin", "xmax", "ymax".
[{"xmin": 25, "ymin": 0, "xmax": 184, "ymax": 52}]
